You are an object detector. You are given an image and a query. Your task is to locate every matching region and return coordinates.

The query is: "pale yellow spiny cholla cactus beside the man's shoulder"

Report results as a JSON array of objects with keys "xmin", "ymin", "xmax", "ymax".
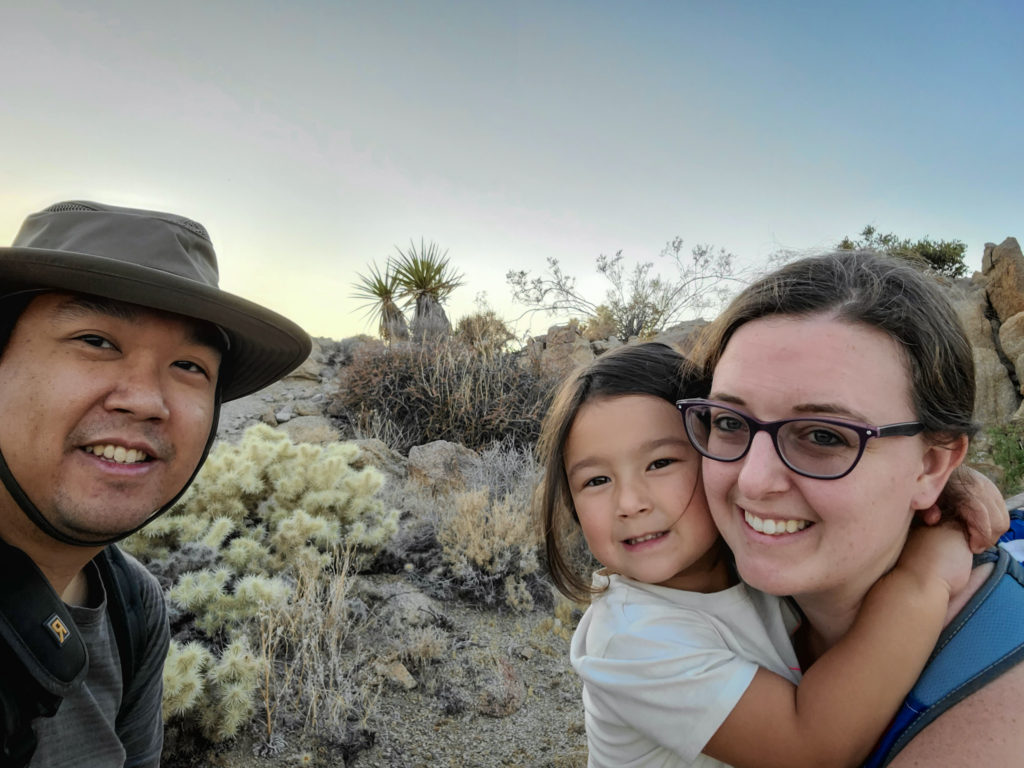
[{"xmin": 124, "ymin": 425, "xmax": 398, "ymax": 741}]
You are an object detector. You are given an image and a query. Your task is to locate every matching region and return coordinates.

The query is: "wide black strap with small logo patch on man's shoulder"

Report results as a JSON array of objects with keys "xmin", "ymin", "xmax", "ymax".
[{"xmin": 0, "ymin": 542, "xmax": 88, "ymax": 768}]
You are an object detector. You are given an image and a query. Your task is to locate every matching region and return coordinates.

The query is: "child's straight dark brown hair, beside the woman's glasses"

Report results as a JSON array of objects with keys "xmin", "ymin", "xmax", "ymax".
[{"xmin": 537, "ymin": 342, "xmax": 708, "ymax": 601}]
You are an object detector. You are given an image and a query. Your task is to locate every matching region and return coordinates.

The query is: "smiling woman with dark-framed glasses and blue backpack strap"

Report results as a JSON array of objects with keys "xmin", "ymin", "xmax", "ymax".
[{"xmin": 679, "ymin": 254, "xmax": 1024, "ymax": 766}]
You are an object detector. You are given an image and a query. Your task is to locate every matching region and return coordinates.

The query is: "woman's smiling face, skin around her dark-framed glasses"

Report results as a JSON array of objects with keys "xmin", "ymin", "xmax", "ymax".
[{"xmin": 703, "ymin": 315, "xmax": 932, "ymax": 606}]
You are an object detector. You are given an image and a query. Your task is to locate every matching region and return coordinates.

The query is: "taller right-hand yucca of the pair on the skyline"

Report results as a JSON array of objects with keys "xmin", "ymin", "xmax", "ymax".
[{"xmin": 393, "ymin": 239, "xmax": 463, "ymax": 343}]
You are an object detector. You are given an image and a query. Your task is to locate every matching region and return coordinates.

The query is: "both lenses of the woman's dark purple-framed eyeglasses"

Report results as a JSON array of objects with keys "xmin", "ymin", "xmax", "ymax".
[{"xmin": 686, "ymin": 406, "xmax": 860, "ymax": 477}]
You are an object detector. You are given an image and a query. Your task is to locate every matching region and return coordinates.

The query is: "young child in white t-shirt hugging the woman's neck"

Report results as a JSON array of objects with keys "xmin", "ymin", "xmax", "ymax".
[{"xmin": 540, "ymin": 343, "xmax": 971, "ymax": 768}]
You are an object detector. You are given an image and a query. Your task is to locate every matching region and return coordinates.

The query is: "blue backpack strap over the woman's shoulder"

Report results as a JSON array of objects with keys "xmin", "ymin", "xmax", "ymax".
[{"xmin": 864, "ymin": 507, "xmax": 1024, "ymax": 768}]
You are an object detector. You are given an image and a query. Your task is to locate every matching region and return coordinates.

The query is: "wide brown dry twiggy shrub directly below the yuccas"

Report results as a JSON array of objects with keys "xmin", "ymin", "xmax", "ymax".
[{"xmin": 337, "ymin": 342, "xmax": 552, "ymax": 453}]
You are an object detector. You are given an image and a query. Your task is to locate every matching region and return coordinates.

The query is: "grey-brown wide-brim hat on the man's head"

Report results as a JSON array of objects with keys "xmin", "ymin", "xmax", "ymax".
[{"xmin": 0, "ymin": 201, "xmax": 311, "ymax": 400}]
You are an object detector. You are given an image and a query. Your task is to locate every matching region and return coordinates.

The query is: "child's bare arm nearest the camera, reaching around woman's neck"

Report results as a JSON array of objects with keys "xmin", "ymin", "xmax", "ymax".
[{"xmin": 705, "ymin": 523, "xmax": 971, "ymax": 768}]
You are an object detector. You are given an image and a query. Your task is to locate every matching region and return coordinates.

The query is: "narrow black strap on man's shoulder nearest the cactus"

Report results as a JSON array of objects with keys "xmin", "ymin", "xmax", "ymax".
[{"xmin": 93, "ymin": 544, "xmax": 146, "ymax": 717}]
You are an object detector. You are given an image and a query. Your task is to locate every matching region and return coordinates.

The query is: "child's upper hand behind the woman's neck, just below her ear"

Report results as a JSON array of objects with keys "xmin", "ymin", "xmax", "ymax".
[{"xmin": 918, "ymin": 464, "xmax": 1010, "ymax": 552}]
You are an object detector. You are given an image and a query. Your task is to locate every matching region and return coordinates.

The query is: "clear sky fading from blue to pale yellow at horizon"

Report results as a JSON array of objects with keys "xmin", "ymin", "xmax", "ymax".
[{"xmin": 0, "ymin": 0, "xmax": 1024, "ymax": 338}]
